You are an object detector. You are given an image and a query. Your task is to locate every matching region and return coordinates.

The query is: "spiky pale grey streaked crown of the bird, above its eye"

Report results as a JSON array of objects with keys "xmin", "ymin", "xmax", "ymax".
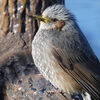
[{"xmin": 42, "ymin": 4, "xmax": 73, "ymax": 20}]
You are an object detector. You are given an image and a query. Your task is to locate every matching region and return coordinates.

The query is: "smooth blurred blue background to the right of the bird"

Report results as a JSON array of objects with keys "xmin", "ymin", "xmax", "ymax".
[{"xmin": 65, "ymin": 0, "xmax": 100, "ymax": 60}]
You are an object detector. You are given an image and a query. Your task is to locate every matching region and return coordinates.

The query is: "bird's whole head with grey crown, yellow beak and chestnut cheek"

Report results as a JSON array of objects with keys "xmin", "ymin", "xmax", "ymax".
[{"xmin": 30, "ymin": 4, "xmax": 74, "ymax": 30}]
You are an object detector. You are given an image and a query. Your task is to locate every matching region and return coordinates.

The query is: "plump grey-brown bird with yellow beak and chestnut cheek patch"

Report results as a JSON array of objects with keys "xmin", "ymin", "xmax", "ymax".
[{"xmin": 32, "ymin": 4, "xmax": 100, "ymax": 100}]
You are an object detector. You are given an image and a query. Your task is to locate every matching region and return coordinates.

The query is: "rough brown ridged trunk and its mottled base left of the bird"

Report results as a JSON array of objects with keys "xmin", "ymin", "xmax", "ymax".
[{"xmin": 0, "ymin": 0, "xmax": 64, "ymax": 100}]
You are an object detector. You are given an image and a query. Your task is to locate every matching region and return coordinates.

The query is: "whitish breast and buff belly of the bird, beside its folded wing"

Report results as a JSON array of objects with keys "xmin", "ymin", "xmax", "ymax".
[{"xmin": 32, "ymin": 33, "xmax": 80, "ymax": 92}]
